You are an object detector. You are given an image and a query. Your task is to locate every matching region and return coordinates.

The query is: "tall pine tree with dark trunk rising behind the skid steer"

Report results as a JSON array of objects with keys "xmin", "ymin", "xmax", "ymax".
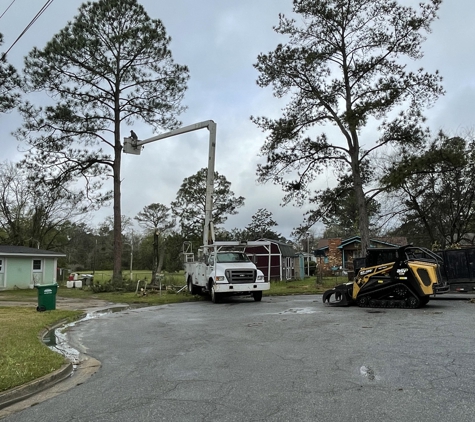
[{"xmin": 252, "ymin": 0, "xmax": 443, "ymax": 250}]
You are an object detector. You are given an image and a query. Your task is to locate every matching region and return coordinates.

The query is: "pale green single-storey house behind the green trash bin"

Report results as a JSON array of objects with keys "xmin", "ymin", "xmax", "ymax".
[{"xmin": 0, "ymin": 245, "xmax": 66, "ymax": 290}]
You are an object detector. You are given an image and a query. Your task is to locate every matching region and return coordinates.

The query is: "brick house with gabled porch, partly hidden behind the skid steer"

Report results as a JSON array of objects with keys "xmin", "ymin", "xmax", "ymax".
[{"xmin": 313, "ymin": 236, "xmax": 407, "ymax": 274}]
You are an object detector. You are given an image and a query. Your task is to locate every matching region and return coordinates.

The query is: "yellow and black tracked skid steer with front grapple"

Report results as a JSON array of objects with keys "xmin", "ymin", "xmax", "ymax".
[{"xmin": 323, "ymin": 245, "xmax": 449, "ymax": 308}]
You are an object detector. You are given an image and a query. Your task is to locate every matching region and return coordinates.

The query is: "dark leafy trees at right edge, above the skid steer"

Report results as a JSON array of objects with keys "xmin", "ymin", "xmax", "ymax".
[{"xmin": 382, "ymin": 133, "xmax": 475, "ymax": 248}]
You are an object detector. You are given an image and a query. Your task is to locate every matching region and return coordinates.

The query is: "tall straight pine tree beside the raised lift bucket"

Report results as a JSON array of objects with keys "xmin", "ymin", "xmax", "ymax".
[{"xmin": 17, "ymin": 0, "xmax": 188, "ymax": 282}]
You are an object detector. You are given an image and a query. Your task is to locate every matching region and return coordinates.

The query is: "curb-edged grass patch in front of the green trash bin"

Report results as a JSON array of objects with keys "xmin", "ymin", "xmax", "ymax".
[{"xmin": 0, "ymin": 307, "xmax": 81, "ymax": 391}]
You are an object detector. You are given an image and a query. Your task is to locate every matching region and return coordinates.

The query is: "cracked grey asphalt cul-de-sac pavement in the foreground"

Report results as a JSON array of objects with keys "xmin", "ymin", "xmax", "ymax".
[{"xmin": 3, "ymin": 296, "xmax": 475, "ymax": 422}]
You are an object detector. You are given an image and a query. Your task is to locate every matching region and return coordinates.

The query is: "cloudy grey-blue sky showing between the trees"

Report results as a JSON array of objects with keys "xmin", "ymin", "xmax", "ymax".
[{"xmin": 0, "ymin": 0, "xmax": 475, "ymax": 237}]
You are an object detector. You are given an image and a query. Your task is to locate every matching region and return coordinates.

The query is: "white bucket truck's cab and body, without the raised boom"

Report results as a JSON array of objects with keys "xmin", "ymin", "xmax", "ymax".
[{"xmin": 184, "ymin": 241, "xmax": 270, "ymax": 303}]
